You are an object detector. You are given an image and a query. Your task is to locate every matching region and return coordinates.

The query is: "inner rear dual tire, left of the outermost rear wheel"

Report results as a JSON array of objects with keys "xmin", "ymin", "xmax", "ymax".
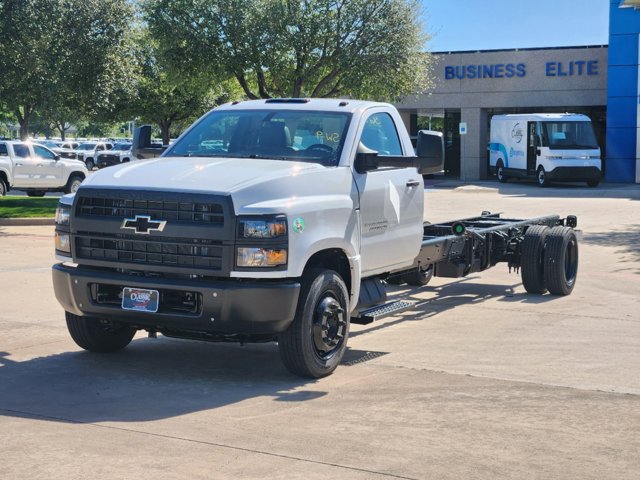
[{"xmin": 520, "ymin": 225, "xmax": 550, "ymax": 294}]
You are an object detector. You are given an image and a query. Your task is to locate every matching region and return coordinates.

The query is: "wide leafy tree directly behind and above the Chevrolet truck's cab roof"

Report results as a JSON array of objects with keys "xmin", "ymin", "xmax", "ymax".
[{"xmin": 144, "ymin": 0, "xmax": 431, "ymax": 99}]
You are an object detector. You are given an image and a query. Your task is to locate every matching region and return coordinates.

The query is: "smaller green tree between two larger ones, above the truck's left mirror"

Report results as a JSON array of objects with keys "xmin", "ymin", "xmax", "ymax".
[{"xmin": 129, "ymin": 30, "xmax": 239, "ymax": 145}]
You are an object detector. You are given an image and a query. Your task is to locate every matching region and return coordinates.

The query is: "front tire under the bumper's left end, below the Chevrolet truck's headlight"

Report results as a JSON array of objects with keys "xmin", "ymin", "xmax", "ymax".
[{"xmin": 65, "ymin": 312, "xmax": 136, "ymax": 353}]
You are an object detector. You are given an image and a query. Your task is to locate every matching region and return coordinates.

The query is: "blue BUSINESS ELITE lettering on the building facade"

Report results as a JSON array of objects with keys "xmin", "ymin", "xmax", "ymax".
[{"xmin": 444, "ymin": 60, "xmax": 600, "ymax": 80}]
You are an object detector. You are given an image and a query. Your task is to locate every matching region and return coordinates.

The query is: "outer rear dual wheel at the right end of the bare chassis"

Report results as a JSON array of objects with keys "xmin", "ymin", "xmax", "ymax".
[{"xmin": 544, "ymin": 227, "xmax": 578, "ymax": 295}]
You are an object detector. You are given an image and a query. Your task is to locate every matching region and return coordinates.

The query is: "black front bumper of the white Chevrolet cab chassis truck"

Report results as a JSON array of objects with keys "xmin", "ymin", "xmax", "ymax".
[{"xmin": 52, "ymin": 263, "xmax": 300, "ymax": 335}]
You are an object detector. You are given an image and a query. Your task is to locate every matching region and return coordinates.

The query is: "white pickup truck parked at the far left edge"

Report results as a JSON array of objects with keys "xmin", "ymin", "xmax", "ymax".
[{"xmin": 0, "ymin": 141, "xmax": 88, "ymax": 197}]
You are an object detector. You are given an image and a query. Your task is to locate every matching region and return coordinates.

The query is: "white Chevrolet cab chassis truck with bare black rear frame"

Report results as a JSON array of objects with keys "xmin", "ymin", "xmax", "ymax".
[{"xmin": 53, "ymin": 99, "xmax": 578, "ymax": 377}]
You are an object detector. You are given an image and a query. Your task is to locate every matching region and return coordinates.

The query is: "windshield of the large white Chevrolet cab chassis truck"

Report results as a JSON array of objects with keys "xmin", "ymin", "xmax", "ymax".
[{"xmin": 165, "ymin": 110, "xmax": 351, "ymax": 166}]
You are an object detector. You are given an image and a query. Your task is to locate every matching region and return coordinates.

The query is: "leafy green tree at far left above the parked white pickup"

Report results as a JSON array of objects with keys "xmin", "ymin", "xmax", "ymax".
[{"xmin": 0, "ymin": 0, "xmax": 132, "ymax": 139}]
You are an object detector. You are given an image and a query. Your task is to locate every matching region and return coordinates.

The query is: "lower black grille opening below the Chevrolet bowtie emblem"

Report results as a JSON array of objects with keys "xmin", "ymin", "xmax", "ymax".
[{"xmin": 75, "ymin": 232, "xmax": 225, "ymax": 271}]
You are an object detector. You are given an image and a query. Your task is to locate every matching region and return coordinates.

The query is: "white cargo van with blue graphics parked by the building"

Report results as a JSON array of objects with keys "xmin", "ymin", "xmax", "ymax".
[{"xmin": 489, "ymin": 113, "xmax": 602, "ymax": 187}]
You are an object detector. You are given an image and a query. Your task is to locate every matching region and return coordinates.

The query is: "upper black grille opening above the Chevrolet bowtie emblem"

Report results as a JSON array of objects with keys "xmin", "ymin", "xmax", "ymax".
[{"xmin": 76, "ymin": 197, "xmax": 224, "ymax": 226}]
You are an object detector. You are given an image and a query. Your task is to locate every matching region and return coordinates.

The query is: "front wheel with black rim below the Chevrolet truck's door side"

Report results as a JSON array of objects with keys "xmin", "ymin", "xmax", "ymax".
[{"xmin": 278, "ymin": 268, "xmax": 350, "ymax": 378}]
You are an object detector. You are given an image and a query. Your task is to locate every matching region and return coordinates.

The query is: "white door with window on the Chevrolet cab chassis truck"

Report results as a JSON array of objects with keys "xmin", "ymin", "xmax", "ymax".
[{"xmin": 354, "ymin": 109, "xmax": 424, "ymax": 276}]
